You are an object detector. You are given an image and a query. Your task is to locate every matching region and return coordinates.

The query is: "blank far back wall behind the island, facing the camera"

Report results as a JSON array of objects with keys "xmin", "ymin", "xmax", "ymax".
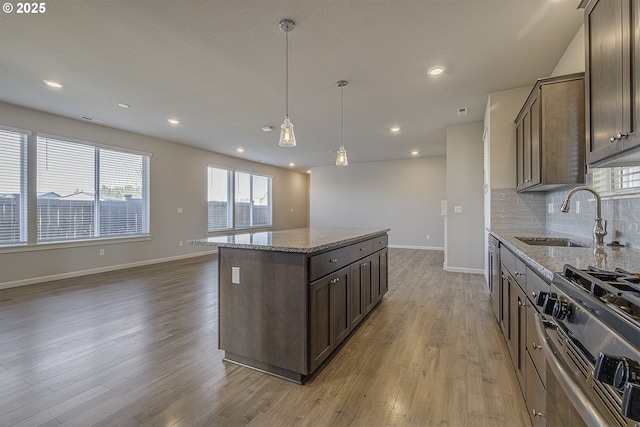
[{"xmin": 309, "ymin": 157, "xmax": 446, "ymax": 249}]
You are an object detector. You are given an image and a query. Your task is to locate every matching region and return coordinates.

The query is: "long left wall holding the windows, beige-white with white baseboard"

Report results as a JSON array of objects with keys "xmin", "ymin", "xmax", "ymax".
[{"xmin": 0, "ymin": 103, "xmax": 309, "ymax": 288}]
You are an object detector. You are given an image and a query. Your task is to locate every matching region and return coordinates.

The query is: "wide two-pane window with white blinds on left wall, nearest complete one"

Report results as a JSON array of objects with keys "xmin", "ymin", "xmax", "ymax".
[{"xmin": 36, "ymin": 137, "xmax": 150, "ymax": 242}]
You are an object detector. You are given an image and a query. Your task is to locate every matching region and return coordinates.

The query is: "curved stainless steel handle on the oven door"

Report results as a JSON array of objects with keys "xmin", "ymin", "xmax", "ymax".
[{"xmin": 536, "ymin": 313, "xmax": 609, "ymax": 426}]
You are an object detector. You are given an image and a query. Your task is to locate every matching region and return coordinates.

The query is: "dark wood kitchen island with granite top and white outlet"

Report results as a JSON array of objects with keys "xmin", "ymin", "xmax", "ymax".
[{"xmin": 189, "ymin": 228, "xmax": 389, "ymax": 383}]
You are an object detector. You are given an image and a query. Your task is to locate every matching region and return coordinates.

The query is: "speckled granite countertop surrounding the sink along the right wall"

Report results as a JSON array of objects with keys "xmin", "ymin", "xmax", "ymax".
[{"xmin": 489, "ymin": 228, "xmax": 640, "ymax": 280}]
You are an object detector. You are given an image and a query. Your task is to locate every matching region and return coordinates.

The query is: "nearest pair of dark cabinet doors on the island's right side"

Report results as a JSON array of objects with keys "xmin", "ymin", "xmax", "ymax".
[{"xmin": 309, "ymin": 267, "xmax": 351, "ymax": 370}]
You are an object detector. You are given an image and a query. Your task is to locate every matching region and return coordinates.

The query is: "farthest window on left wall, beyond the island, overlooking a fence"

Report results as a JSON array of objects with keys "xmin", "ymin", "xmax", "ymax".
[{"xmin": 207, "ymin": 166, "xmax": 272, "ymax": 231}]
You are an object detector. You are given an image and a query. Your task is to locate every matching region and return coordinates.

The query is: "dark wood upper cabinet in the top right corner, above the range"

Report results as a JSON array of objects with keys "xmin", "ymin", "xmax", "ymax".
[{"xmin": 580, "ymin": 0, "xmax": 640, "ymax": 167}]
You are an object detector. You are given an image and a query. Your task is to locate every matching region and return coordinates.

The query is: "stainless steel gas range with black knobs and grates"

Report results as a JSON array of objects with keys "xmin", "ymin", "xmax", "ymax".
[{"xmin": 536, "ymin": 265, "xmax": 640, "ymax": 427}]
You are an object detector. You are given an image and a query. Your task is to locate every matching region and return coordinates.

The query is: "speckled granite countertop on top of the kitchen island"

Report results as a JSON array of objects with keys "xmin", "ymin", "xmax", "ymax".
[{"xmin": 187, "ymin": 227, "xmax": 389, "ymax": 253}]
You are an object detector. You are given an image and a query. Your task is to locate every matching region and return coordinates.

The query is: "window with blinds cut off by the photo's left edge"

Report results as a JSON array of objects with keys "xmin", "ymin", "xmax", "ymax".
[{"xmin": 0, "ymin": 129, "xmax": 28, "ymax": 245}]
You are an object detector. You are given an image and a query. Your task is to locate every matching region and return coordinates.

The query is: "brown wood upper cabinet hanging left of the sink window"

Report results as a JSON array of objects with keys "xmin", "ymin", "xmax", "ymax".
[{"xmin": 515, "ymin": 73, "xmax": 585, "ymax": 192}]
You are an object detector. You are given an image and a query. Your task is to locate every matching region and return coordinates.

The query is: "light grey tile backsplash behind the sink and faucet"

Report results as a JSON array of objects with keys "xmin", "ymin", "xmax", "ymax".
[{"xmin": 491, "ymin": 188, "xmax": 640, "ymax": 248}]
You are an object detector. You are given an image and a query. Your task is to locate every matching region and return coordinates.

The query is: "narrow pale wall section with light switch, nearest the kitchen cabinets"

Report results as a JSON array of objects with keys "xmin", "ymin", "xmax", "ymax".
[{"xmin": 445, "ymin": 122, "xmax": 485, "ymax": 274}]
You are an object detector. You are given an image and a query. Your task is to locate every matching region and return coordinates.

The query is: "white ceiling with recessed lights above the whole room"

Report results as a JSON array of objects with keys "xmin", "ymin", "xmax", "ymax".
[{"xmin": 0, "ymin": 0, "xmax": 583, "ymax": 170}]
